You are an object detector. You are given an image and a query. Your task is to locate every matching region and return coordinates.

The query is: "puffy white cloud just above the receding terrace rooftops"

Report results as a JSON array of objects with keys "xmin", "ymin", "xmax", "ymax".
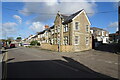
[{"xmin": 29, "ymin": 22, "xmax": 44, "ymax": 32}]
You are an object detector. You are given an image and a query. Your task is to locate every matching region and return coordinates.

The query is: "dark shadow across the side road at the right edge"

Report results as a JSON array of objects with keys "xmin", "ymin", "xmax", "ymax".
[{"xmin": 95, "ymin": 43, "xmax": 120, "ymax": 53}]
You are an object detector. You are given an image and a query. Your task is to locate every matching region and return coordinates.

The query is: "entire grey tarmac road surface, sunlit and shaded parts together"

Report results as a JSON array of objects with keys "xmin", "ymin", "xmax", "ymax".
[{"xmin": 7, "ymin": 47, "xmax": 118, "ymax": 78}]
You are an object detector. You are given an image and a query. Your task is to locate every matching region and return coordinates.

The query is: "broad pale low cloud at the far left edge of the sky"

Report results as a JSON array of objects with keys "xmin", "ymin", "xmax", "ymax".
[{"xmin": 1, "ymin": 22, "xmax": 17, "ymax": 36}]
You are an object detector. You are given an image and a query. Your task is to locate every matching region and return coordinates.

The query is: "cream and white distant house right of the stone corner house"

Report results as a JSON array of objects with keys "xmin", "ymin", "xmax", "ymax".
[{"xmin": 90, "ymin": 27, "xmax": 109, "ymax": 47}]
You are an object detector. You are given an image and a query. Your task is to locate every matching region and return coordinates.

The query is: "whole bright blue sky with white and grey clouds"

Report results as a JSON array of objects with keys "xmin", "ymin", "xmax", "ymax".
[{"xmin": 0, "ymin": 0, "xmax": 118, "ymax": 39}]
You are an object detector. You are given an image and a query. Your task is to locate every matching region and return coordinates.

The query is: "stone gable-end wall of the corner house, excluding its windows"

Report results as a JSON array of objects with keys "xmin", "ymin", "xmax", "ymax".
[{"xmin": 72, "ymin": 10, "xmax": 92, "ymax": 51}]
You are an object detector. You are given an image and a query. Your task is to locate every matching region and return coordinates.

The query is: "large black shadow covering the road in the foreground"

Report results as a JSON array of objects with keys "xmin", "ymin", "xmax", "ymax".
[{"xmin": 7, "ymin": 56, "xmax": 117, "ymax": 80}]
